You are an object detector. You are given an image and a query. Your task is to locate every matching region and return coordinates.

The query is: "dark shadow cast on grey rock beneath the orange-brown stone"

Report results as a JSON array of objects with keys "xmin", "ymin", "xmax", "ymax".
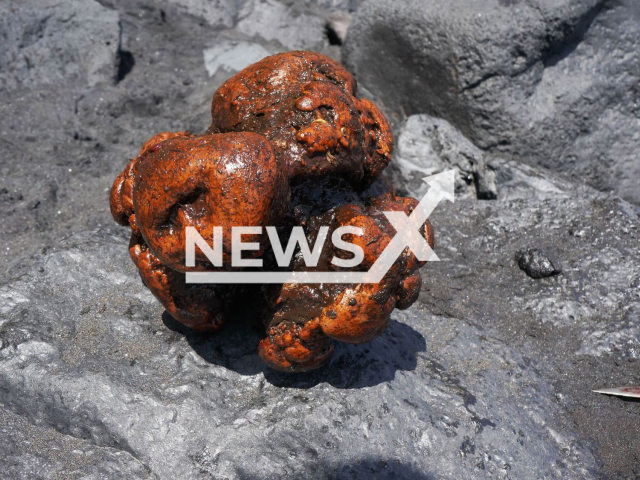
[{"xmin": 162, "ymin": 312, "xmax": 427, "ymax": 389}]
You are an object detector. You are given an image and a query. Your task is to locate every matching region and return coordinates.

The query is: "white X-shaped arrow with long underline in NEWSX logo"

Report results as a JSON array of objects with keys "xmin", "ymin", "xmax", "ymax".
[{"xmin": 186, "ymin": 170, "xmax": 455, "ymax": 283}]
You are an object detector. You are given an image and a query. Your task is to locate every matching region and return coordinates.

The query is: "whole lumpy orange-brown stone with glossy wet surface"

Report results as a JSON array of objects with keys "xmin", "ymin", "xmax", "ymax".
[{"xmin": 111, "ymin": 52, "xmax": 433, "ymax": 372}]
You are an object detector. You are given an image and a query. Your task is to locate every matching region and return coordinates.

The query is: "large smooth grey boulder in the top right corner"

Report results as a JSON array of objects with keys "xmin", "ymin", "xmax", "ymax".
[{"xmin": 344, "ymin": 0, "xmax": 640, "ymax": 203}]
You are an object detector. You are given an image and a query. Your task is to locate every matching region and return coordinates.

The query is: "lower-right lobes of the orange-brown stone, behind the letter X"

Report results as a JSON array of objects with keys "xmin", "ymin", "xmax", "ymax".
[{"xmin": 259, "ymin": 179, "xmax": 434, "ymax": 371}]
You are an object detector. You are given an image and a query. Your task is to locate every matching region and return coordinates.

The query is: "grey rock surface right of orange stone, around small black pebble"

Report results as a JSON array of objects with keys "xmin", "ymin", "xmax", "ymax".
[{"xmin": 419, "ymin": 182, "xmax": 640, "ymax": 478}]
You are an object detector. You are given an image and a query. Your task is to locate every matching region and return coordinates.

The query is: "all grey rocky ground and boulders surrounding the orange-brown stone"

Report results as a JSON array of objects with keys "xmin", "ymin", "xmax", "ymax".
[{"xmin": 0, "ymin": 0, "xmax": 640, "ymax": 479}]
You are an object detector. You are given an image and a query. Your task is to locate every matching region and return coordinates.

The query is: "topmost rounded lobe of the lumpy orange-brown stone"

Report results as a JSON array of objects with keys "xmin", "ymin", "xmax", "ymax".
[{"xmin": 209, "ymin": 52, "xmax": 393, "ymax": 183}]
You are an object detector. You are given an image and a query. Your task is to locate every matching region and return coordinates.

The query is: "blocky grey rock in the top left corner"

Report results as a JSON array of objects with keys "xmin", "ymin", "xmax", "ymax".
[{"xmin": 0, "ymin": 0, "xmax": 120, "ymax": 90}]
